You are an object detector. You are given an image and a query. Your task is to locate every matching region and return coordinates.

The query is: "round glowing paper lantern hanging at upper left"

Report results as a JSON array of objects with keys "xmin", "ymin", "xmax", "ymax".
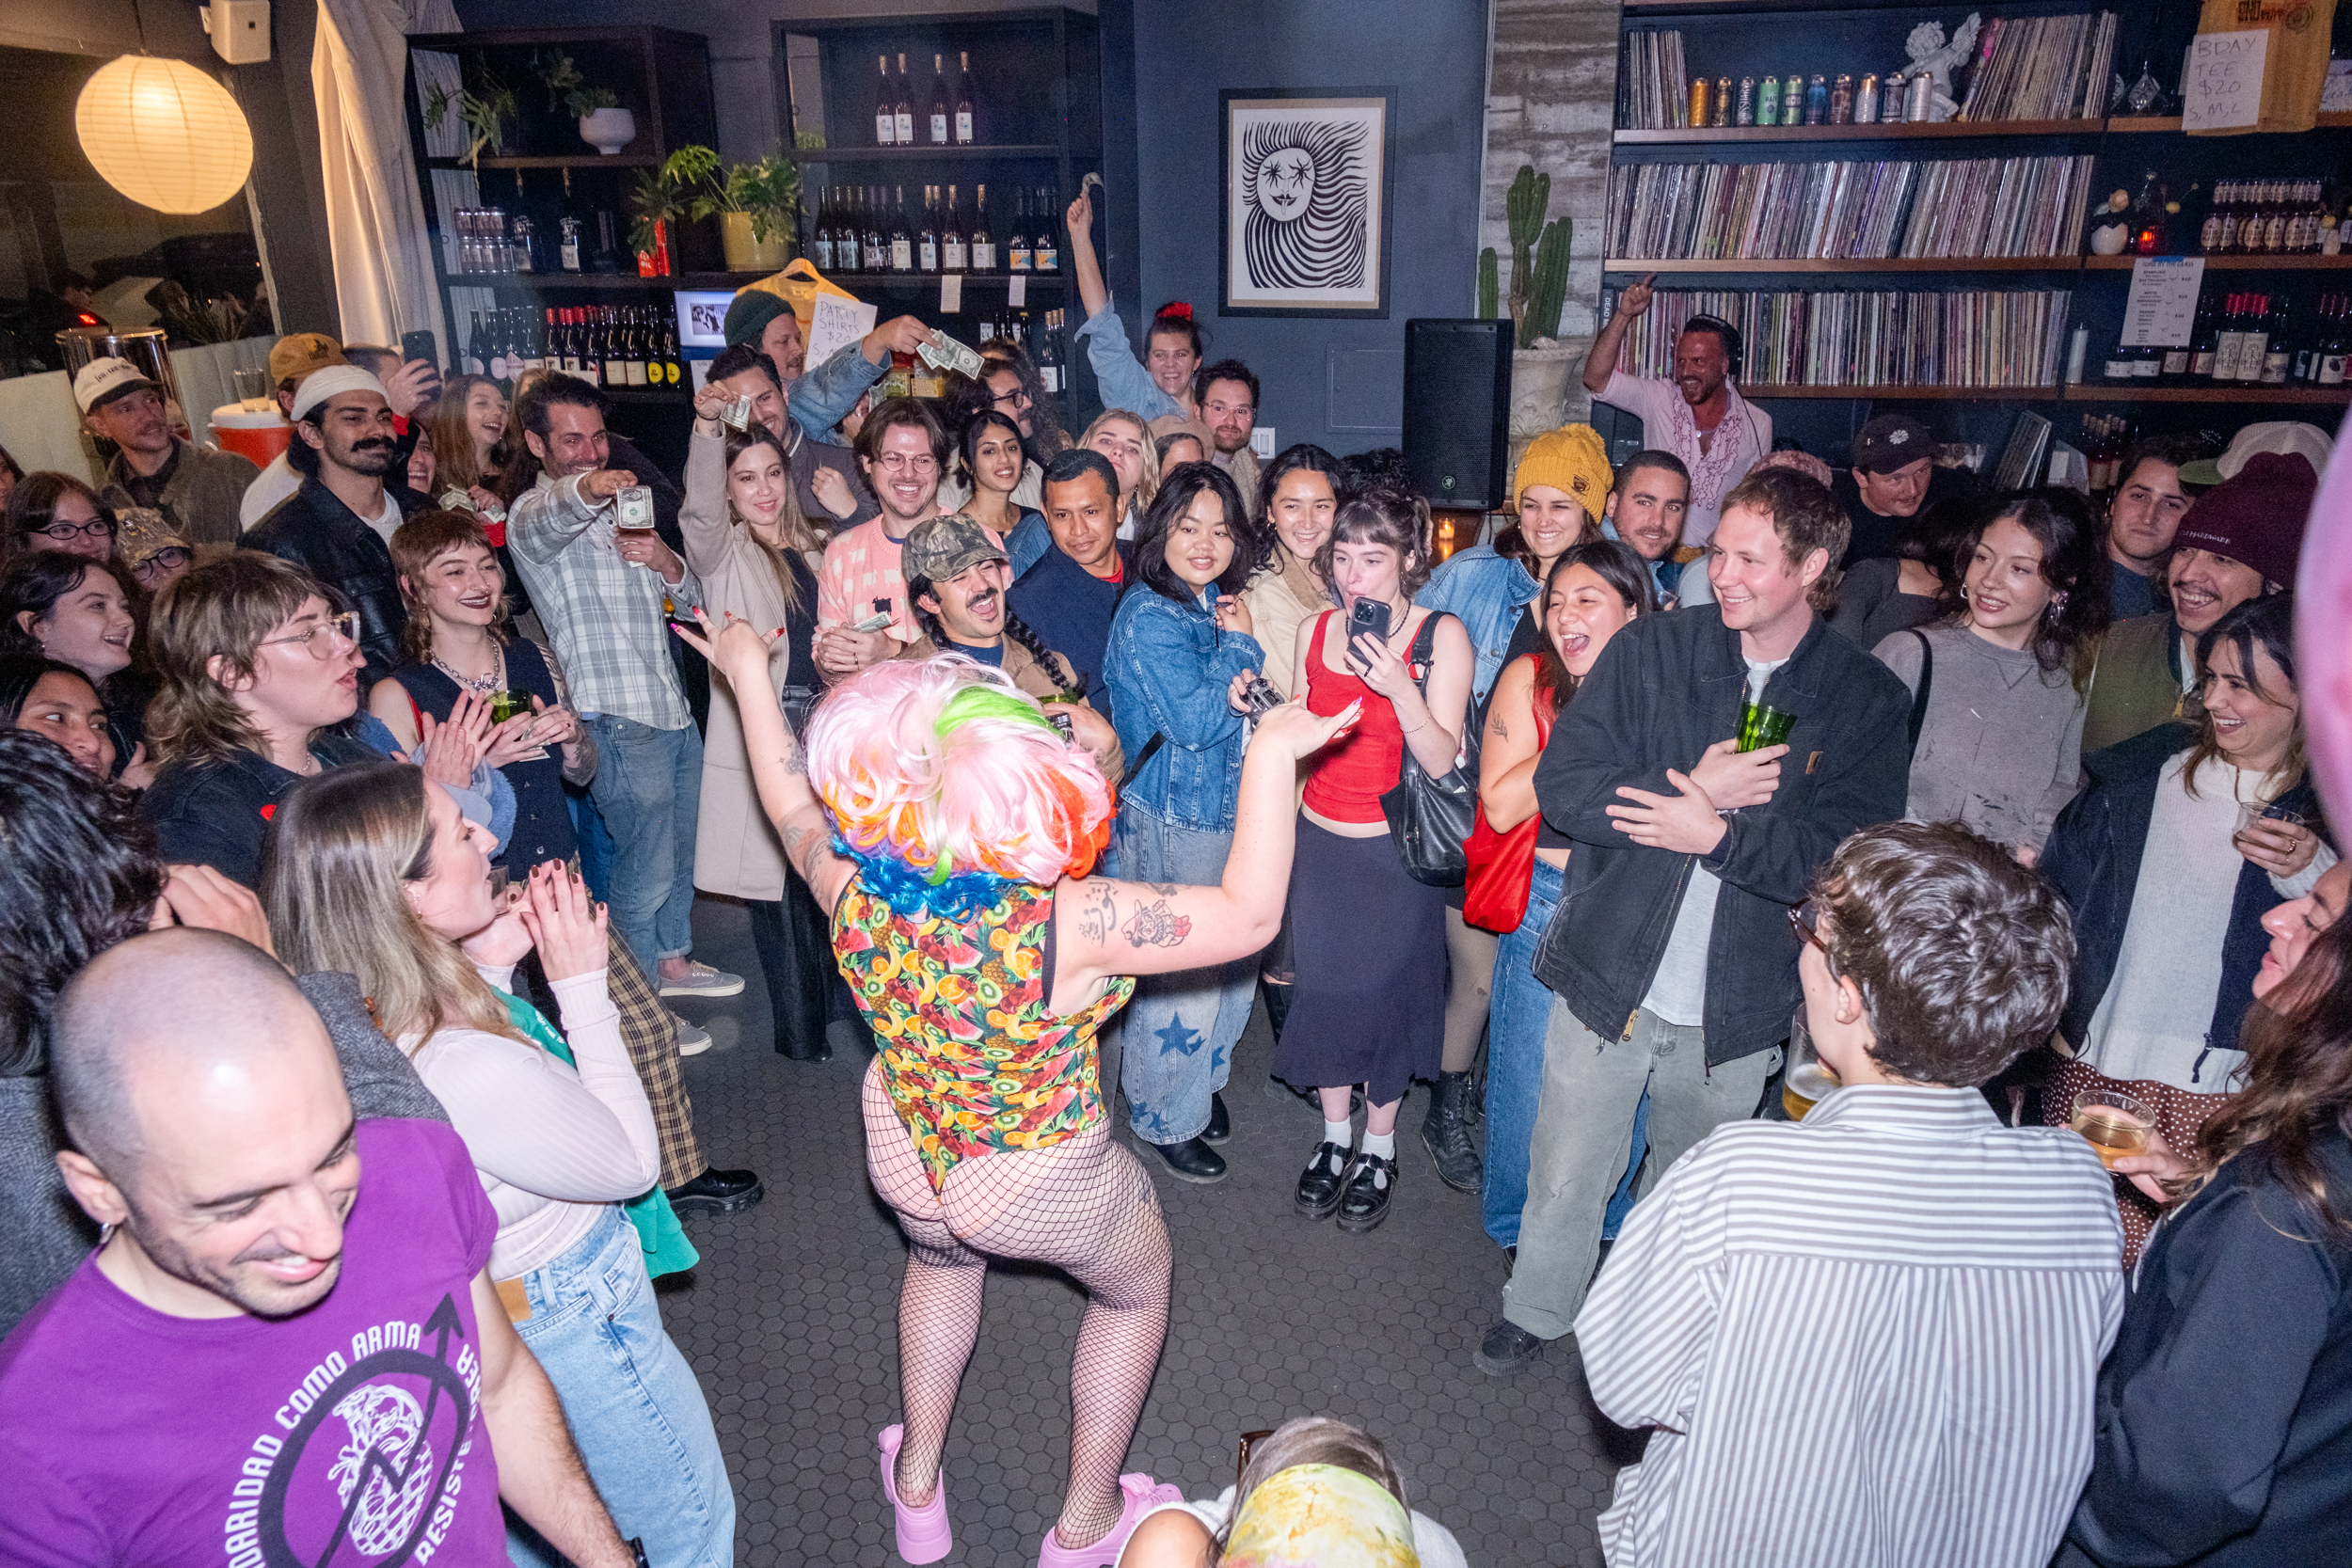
[{"xmin": 73, "ymin": 54, "xmax": 254, "ymax": 212}]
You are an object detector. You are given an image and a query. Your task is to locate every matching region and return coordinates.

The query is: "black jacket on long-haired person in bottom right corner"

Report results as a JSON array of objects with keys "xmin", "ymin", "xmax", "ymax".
[{"xmin": 2058, "ymin": 1131, "xmax": 2352, "ymax": 1568}]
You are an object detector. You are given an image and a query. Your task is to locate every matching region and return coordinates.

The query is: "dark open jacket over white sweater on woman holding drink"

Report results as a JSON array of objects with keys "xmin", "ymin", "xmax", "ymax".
[{"xmin": 2042, "ymin": 724, "xmax": 2319, "ymax": 1093}]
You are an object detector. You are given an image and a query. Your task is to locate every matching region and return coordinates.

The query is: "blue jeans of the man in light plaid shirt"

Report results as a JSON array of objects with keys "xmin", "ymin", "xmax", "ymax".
[{"xmin": 588, "ymin": 712, "xmax": 704, "ymax": 985}]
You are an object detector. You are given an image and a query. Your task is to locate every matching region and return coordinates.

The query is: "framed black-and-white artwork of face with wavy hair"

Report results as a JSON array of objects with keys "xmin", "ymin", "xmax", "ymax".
[{"xmin": 1216, "ymin": 87, "xmax": 1397, "ymax": 320}]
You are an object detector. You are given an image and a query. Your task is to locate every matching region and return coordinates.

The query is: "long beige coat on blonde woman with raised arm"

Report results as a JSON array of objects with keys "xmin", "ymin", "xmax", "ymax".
[{"xmin": 677, "ymin": 435, "xmax": 817, "ymax": 900}]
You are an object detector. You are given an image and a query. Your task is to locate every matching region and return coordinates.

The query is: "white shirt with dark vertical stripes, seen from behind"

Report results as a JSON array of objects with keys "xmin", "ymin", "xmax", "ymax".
[{"xmin": 1576, "ymin": 1084, "xmax": 2124, "ymax": 1568}]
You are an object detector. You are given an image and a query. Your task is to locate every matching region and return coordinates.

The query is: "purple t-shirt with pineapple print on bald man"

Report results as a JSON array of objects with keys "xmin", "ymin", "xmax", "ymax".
[{"xmin": 0, "ymin": 1121, "xmax": 506, "ymax": 1568}]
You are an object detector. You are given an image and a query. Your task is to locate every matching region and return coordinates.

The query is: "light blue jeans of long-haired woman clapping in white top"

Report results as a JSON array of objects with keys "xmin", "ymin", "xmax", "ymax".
[{"xmin": 506, "ymin": 1204, "xmax": 734, "ymax": 1568}]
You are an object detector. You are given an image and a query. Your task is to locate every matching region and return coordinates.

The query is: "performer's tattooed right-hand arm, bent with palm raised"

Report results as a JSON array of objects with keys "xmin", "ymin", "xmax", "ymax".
[{"xmin": 1052, "ymin": 703, "xmax": 1362, "ymax": 1013}]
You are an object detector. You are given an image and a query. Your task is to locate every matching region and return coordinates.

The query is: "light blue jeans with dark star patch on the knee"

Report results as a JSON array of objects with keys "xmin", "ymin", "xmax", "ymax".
[{"xmin": 1115, "ymin": 806, "xmax": 1256, "ymax": 1143}]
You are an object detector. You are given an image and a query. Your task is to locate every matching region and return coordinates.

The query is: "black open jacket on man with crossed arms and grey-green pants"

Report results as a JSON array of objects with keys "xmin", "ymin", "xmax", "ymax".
[{"xmin": 1536, "ymin": 604, "xmax": 1910, "ymax": 1068}]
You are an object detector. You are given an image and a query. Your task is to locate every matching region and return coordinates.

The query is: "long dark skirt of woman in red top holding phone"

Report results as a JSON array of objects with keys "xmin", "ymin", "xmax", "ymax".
[{"xmin": 1275, "ymin": 818, "xmax": 1447, "ymax": 1105}]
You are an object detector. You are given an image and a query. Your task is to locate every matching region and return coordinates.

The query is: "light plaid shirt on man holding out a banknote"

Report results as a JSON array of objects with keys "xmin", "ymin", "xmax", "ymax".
[{"xmin": 506, "ymin": 475, "xmax": 704, "ymax": 729}]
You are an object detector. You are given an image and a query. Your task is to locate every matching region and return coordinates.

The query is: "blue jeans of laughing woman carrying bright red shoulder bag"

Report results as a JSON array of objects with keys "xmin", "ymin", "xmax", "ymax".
[{"xmin": 1480, "ymin": 861, "xmax": 1649, "ymax": 1246}]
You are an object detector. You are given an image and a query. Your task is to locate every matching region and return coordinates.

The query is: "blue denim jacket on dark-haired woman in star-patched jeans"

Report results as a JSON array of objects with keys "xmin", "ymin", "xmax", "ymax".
[{"xmin": 1104, "ymin": 583, "xmax": 1265, "ymax": 832}]
